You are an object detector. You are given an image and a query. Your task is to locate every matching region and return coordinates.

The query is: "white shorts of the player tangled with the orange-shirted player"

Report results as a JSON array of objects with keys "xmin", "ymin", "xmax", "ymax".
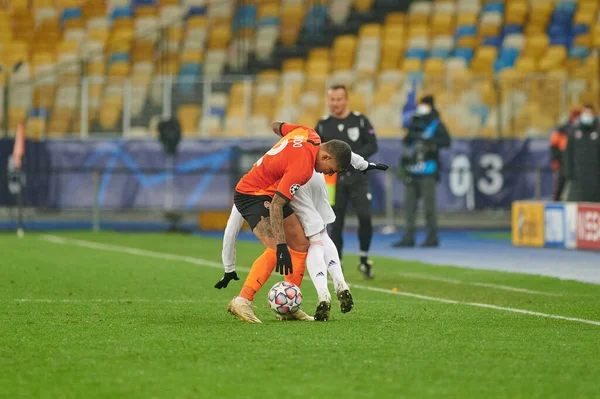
[{"xmin": 290, "ymin": 172, "xmax": 335, "ymax": 237}]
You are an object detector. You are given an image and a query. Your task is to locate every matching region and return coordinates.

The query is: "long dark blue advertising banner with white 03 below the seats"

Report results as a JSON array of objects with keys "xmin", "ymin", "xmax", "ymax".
[{"xmin": 0, "ymin": 137, "xmax": 552, "ymax": 211}]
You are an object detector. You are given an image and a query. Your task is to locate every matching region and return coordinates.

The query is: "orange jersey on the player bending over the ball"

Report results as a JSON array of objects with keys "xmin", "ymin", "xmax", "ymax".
[{"xmin": 235, "ymin": 123, "xmax": 321, "ymax": 200}]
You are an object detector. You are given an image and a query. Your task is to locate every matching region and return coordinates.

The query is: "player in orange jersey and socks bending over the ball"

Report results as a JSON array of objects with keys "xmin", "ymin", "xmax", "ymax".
[{"xmin": 216, "ymin": 122, "xmax": 352, "ymax": 323}]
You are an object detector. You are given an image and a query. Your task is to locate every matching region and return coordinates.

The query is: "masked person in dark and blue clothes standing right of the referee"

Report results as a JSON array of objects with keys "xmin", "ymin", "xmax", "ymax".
[{"xmin": 393, "ymin": 96, "xmax": 450, "ymax": 247}]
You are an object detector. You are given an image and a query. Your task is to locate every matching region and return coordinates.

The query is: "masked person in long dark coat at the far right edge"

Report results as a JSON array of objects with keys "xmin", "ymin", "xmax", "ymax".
[{"xmin": 565, "ymin": 105, "xmax": 600, "ymax": 202}]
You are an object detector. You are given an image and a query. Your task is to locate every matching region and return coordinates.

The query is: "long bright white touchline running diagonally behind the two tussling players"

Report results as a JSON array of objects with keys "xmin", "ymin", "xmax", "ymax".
[{"xmin": 40, "ymin": 235, "xmax": 600, "ymax": 326}]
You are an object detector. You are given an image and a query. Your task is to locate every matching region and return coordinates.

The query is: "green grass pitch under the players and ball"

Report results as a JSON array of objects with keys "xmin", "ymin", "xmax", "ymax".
[{"xmin": 0, "ymin": 232, "xmax": 600, "ymax": 399}]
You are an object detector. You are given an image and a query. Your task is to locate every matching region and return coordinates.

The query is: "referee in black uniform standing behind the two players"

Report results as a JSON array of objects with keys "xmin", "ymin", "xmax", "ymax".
[{"xmin": 315, "ymin": 85, "xmax": 377, "ymax": 279}]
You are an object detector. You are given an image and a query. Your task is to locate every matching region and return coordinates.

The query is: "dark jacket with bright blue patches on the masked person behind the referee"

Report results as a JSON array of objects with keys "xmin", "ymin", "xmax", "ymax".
[{"xmin": 401, "ymin": 108, "xmax": 450, "ymax": 179}]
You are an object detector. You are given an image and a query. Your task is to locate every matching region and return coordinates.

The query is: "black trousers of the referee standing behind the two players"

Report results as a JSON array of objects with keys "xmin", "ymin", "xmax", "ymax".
[{"xmin": 329, "ymin": 172, "xmax": 373, "ymax": 259}]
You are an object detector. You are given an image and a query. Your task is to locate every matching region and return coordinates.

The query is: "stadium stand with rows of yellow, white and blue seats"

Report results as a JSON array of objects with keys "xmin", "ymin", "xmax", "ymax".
[{"xmin": 0, "ymin": 0, "xmax": 600, "ymax": 138}]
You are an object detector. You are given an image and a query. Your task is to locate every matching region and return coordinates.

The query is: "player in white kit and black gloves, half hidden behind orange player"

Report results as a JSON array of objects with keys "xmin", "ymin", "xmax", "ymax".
[{"xmin": 215, "ymin": 153, "xmax": 387, "ymax": 321}]
